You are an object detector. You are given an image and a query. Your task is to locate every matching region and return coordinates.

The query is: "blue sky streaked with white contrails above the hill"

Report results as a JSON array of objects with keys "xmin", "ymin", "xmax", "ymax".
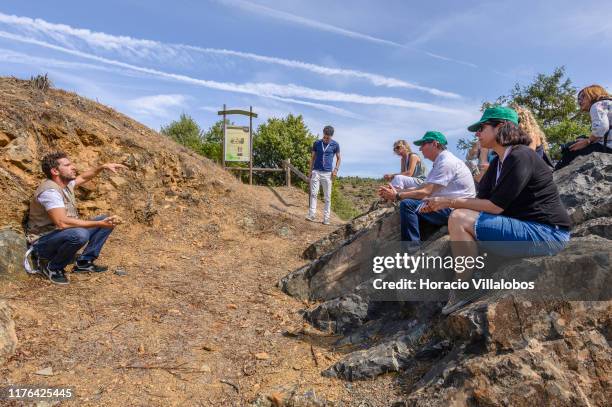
[{"xmin": 0, "ymin": 0, "xmax": 612, "ymax": 176}]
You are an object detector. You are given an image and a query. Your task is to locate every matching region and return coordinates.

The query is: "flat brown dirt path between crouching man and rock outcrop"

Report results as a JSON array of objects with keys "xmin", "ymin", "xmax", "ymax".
[{"xmin": 0, "ymin": 187, "xmax": 394, "ymax": 406}]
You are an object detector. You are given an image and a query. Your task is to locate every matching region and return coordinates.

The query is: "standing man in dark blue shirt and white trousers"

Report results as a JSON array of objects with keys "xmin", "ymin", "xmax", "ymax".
[{"xmin": 306, "ymin": 126, "xmax": 341, "ymax": 225}]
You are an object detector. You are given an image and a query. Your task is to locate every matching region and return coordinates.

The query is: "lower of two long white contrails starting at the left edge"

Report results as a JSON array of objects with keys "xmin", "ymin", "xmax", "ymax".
[{"xmin": 0, "ymin": 31, "xmax": 461, "ymax": 114}]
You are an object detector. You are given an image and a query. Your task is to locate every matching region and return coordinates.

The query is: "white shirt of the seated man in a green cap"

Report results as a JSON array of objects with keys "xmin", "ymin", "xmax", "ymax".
[{"xmin": 425, "ymin": 150, "xmax": 476, "ymax": 198}]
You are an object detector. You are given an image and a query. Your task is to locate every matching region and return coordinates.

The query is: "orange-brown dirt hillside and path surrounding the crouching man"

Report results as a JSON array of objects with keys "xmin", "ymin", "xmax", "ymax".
[{"xmin": 0, "ymin": 78, "xmax": 406, "ymax": 406}]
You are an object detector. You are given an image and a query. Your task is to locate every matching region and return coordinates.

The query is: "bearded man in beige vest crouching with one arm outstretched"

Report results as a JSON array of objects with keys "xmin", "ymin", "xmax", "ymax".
[{"xmin": 27, "ymin": 152, "xmax": 126, "ymax": 284}]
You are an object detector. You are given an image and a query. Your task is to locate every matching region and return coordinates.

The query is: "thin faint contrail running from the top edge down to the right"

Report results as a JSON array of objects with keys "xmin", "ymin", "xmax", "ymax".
[{"xmin": 217, "ymin": 0, "xmax": 478, "ymax": 68}]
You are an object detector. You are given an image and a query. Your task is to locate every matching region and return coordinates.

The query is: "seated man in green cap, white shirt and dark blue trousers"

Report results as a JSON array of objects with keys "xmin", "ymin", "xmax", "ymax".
[{"xmin": 378, "ymin": 131, "xmax": 476, "ymax": 242}]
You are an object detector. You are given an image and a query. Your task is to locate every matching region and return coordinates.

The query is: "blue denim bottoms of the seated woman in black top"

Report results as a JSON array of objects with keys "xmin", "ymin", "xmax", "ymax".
[{"xmin": 474, "ymin": 212, "xmax": 570, "ymax": 256}]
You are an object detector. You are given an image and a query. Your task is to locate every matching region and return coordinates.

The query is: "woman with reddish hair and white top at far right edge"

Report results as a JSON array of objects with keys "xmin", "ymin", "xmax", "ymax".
[{"xmin": 555, "ymin": 85, "xmax": 612, "ymax": 171}]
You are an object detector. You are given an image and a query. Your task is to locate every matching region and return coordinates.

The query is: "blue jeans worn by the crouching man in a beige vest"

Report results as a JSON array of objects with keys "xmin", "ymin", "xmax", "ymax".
[{"xmin": 34, "ymin": 215, "xmax": 113, "ymax": 270}]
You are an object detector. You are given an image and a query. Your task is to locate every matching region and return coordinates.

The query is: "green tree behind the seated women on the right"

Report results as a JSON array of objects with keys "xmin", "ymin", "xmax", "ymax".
[{"xmin": 458, "ymin": 66, "xmax": 589, "ymax": 156}]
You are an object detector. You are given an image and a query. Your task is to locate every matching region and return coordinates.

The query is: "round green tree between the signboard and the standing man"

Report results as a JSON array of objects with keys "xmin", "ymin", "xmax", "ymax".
[{"xmin": 253, "ymin": 114, "xmax": 316, "ymax": 184}]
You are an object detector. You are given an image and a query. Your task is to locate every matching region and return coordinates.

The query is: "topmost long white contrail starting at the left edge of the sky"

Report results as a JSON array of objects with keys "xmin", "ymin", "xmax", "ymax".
[{"xmin": 0, "ymin": 13, "xmax": 461, "ymax": 99}]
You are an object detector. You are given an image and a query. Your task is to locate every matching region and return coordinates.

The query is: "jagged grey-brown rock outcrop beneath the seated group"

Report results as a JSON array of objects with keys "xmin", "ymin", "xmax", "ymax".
[{"xmin": 279, "ymin": 154, "xmax": 612, "ymax": 407}]
